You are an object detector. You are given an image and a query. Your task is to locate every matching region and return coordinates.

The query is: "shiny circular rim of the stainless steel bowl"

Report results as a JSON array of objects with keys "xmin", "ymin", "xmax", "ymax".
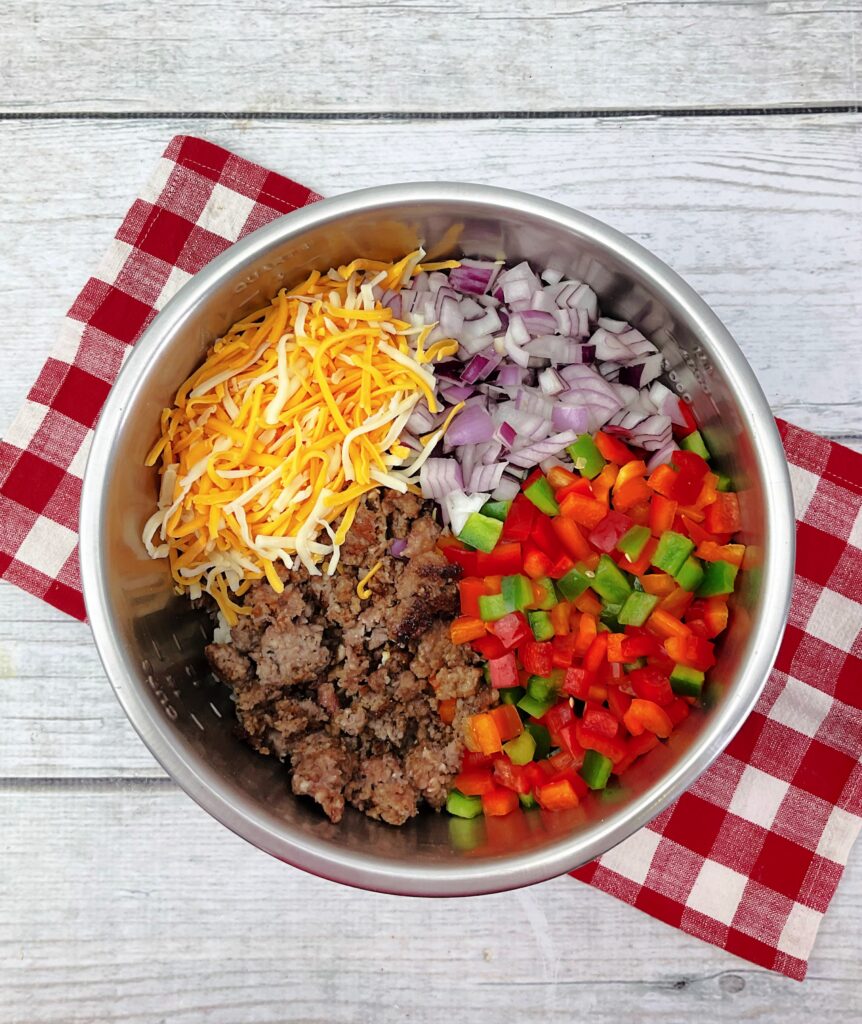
[{"xmin": 80, "ymin": 181, "xmax": 795, "ymax": 896}]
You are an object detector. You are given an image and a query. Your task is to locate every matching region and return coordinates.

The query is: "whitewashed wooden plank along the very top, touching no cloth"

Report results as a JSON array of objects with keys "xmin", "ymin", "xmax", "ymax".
[{"xmin": 0, "ymin": 0, "xmax": 860, "ymax": 113}]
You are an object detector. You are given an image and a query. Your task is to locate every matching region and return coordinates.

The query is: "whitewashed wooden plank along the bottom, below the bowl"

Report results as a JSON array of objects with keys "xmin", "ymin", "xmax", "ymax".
[{"xmin": 0, "ymin": 784, "xmax": 862, "ymax": 1024}]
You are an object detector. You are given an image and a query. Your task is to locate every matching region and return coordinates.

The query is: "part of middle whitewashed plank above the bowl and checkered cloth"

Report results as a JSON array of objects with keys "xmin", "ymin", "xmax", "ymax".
[{"xmin": 0, "ymin": 115, "xmax": 862, "ymax": 458}]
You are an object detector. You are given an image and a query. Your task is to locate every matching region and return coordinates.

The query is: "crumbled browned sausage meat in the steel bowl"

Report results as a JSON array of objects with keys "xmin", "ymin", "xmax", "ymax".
[{"xmin": 207, "ymin": 490, "xmax": 495, "ymax": 825}]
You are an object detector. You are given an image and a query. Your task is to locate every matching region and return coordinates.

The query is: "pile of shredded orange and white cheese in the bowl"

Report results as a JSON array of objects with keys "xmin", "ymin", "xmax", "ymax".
[{"xmin": 143, "ymin": 250, "xmax": 458, "ymax": 626}]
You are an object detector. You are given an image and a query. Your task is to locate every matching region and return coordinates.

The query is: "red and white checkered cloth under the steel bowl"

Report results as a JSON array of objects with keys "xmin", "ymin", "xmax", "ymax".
[{"xmin": 0, "ymin": 136, "xmax": 862, "ymax": 979}]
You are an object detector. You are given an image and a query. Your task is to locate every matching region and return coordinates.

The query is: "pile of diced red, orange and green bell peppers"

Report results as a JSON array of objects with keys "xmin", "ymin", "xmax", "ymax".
[{"xmin": 440, "ymin": 419, "xmax": 745, "ymax": 818}]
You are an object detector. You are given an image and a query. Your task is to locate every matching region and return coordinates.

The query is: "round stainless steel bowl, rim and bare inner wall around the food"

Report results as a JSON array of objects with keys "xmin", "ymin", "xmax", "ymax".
[{"xmin": 81, "ymin": 183, "xmax": 793, "ymax": 896}]
